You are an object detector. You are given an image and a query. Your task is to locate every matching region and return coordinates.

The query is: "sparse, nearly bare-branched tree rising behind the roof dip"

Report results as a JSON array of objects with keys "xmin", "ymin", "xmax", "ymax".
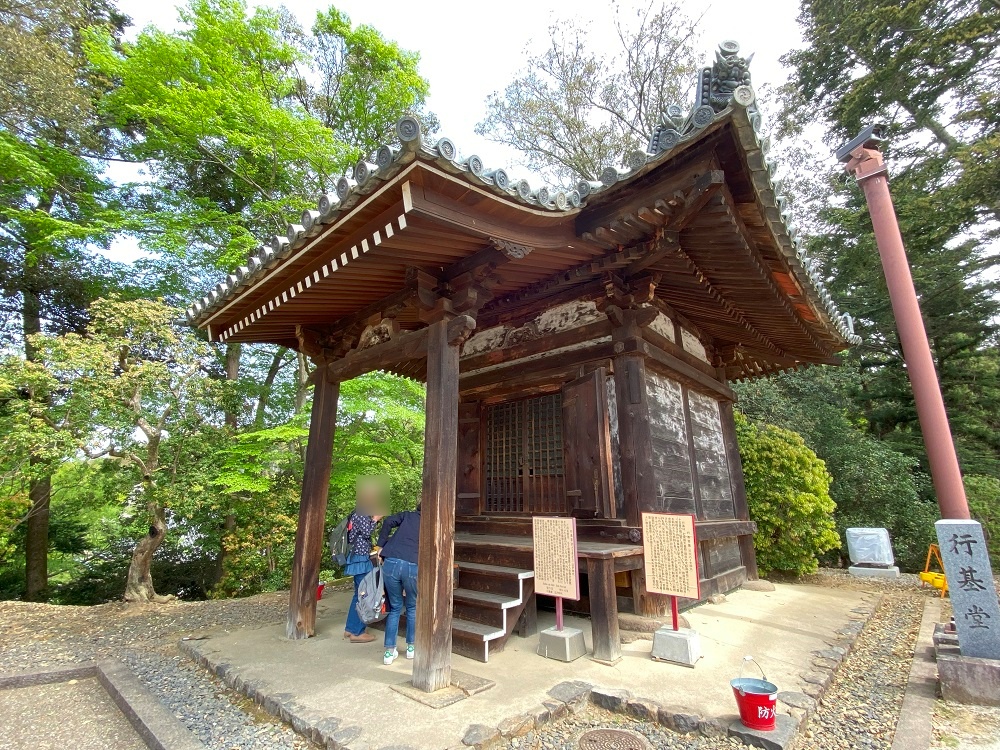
[{"xmin": 476, "ymin": 2, "xmax": 698, "ymax": 183}]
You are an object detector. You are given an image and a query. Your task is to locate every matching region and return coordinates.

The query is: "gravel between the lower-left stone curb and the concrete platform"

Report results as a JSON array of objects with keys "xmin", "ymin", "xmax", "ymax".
[{"xmin": 0, "ymin": 593, "xmax": 315, "ymax": 750}]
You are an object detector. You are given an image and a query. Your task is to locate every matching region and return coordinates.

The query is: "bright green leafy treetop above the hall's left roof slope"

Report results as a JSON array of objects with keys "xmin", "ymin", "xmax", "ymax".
[{"xmin": 89, "ymin": 0, "xmax": 427, "ymax": 280}]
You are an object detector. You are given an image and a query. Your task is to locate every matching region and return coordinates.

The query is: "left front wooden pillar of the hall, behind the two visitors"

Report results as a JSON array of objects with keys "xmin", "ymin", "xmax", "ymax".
[{"xmin": 285, "ymin": 366, "xmax": 340, "ymax": 640}]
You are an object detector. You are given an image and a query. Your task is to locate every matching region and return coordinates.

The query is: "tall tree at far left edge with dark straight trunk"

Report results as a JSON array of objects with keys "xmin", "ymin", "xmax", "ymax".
[{"xmin": 0, "ymin": 0, "xmax": 125, "ymax": 599}]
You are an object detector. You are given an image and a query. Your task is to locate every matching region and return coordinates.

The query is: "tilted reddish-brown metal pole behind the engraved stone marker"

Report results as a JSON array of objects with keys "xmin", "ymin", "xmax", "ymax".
[{"xmin": 846, "ymin": 146, "xmax": 970, "ymax": 518}]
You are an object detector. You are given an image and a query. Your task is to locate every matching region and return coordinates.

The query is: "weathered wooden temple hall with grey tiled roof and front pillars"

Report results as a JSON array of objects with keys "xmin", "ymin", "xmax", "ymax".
[{"xmin": 189, "ymin": 42, "xmax": 855, "ymax": 691}]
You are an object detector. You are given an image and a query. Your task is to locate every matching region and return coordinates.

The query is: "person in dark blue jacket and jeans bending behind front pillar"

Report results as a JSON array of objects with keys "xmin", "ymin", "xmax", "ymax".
[{"xmin": 376, "ymin": 505, "xmax": 420, "ymax": 665}]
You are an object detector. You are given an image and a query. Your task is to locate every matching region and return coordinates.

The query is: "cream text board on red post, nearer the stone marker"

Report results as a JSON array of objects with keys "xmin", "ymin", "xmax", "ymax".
[{"xmin": 642, "ymin": 513, "xmax": 701, "ymax": 599}]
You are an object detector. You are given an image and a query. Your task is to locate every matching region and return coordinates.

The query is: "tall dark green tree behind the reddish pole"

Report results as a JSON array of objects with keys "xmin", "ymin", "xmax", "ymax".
[{"xmin": 781, "ymin": 0, "xmax": 1000, "ymax": 476}]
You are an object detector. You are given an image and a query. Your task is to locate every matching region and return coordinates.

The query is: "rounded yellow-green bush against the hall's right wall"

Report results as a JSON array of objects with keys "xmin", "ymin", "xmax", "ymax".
[{"xmin": 736, "ymin": 414, "xmax": 840, "ymax": 575}]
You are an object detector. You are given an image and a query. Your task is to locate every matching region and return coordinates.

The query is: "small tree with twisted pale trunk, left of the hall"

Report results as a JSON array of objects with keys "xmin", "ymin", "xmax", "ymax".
[{"xmin": 13, "ymin": 297, "xmax": 220, "ymax": 601}]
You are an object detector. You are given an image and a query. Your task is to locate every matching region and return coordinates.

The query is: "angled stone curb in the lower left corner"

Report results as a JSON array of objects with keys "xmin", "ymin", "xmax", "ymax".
[{"xmin": 0, "ymin": 659, "xmax": 205, "ymax": 750}]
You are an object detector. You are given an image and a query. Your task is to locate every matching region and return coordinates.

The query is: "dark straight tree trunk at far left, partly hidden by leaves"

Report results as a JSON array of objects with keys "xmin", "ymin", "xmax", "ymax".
[{"xmin": 21, "ymin": 288, "xmax": 52, "ymax": 602}]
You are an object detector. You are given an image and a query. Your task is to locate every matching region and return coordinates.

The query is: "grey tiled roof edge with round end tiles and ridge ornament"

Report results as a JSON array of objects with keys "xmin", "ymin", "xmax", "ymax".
[{"xmin": 187, "ymin": 41, "xmax": 861, "ymax": 352}]
